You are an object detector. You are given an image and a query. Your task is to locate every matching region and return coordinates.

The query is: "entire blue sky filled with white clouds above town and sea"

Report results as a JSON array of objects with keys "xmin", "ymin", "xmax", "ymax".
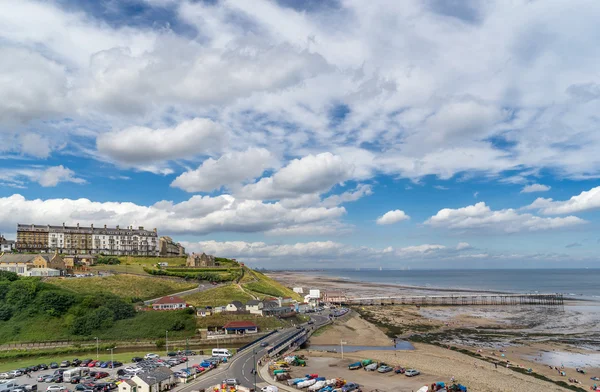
[{"xmin": 0, "ymin": 0, "xmax": 600, "ymax": 269}]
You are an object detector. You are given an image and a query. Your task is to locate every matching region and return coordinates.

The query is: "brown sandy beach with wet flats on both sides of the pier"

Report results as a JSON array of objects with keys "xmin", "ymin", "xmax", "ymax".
[{"xmin": 270, "ymin": 272, "xmax": 600, "ymax": 391}]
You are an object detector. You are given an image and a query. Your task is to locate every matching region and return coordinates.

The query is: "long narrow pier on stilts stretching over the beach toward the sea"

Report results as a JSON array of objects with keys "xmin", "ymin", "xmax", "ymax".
[{"xmin": 343, "ymin": 294, "xmax": 564, "ymax": 306}]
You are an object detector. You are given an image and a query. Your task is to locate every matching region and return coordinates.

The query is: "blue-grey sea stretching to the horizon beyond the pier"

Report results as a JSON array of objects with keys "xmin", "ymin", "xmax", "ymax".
[{"xmin": 306, "ymin": 269, "xmax": 600, "ymax": 300}]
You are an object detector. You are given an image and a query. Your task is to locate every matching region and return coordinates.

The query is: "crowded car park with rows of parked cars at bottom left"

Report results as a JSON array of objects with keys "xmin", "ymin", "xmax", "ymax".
[{"xmin": 0, "ymin": 353, "xmax": 224, "ymax": 392}]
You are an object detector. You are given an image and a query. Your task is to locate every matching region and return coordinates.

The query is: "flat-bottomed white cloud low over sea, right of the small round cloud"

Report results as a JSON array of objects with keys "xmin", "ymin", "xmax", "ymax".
[{"xmin": 425, "ymin": 202, "xmax": 587, "ymax": 233}]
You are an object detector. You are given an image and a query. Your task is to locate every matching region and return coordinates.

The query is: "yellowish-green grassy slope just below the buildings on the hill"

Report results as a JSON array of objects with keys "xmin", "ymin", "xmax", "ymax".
[{"xmin": 47, "ymin": 275, "xmax": 198, "ymax": 299}]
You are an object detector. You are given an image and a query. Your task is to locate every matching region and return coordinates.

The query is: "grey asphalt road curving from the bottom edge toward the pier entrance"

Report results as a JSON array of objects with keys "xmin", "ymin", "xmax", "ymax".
[{"xmin": 178, "ymin": 315, "xmax": 328, "ymax": 392}]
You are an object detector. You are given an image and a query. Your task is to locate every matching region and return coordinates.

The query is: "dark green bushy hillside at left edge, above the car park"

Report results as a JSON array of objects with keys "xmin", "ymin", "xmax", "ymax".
[{"xmin": 0, "ymin": 271, "xmax": 195, "ymax": 343}]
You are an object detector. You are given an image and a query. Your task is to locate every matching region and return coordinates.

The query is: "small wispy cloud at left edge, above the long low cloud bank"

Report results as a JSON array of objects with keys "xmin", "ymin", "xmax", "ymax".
[{"xmin": 2, "ymin": 165, "xmax": 86, "ymax": 188}]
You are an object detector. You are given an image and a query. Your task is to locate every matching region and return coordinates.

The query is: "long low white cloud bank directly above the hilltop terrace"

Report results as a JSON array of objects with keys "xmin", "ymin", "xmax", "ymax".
[{"xmin": 0, "ymin": 194, "xmax": 346, "ymax": 234}]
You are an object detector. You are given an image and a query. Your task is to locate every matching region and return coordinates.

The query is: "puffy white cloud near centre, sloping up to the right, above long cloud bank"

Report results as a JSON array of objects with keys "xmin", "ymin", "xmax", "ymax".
[{"xmin": 238, "ymin": 152, "xmax": 354, "ymax": 200}]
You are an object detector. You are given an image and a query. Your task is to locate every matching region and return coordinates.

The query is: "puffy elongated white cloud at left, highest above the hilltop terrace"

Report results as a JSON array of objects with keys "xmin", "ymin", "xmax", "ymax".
[{"xmin": 97, "ymin": 118, "xmax": 226, "ymax": 164}]
